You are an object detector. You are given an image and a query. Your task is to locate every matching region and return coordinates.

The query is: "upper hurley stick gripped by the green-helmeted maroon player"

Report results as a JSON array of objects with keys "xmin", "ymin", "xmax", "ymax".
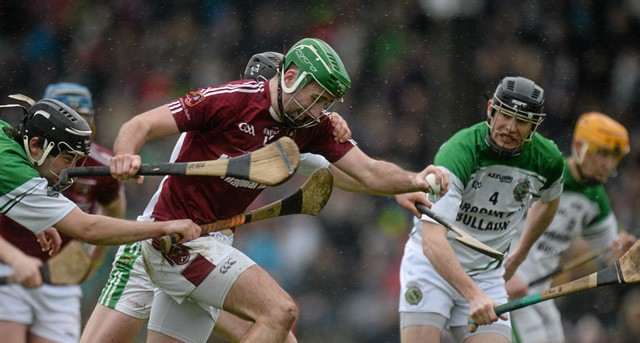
[{"xmin": 60, "ymin": 137, "xmax": 300, "ymax": 188}]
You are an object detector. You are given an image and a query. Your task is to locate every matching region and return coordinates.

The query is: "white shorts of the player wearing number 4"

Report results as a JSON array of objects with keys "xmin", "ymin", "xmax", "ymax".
[{"xmin": 399, "ymin": 245, "xmax": 511, "ymax": 339}]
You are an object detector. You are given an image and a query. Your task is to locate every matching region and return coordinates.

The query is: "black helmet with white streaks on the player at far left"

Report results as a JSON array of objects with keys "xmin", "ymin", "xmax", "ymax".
[{"xmin": 20, "ymin": 99, "xmax": 91, "ymax": 166}]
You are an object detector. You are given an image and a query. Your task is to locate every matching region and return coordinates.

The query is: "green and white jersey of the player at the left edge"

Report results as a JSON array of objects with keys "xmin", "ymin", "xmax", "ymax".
[{"xmin": 0, "ymin": 121, "xmax": 76, "ymax": 234}]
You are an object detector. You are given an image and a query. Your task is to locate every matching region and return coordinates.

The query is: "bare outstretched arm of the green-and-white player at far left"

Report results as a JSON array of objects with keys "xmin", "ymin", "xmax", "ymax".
[{"xmin": 54, "ymin": 207, "xmax": 201, "ymax": 245}]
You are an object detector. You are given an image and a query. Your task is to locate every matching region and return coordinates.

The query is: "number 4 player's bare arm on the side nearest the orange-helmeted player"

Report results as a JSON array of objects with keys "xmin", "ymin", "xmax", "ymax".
[{"xmin": 504, "ymin": 197, "xmax": 560, "ymax": 281}]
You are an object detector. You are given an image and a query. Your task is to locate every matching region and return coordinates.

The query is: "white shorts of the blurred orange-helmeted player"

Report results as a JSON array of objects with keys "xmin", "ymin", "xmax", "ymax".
[{"xmin": 511, "ymin": 299, "xmax": 564, "ymax": 343}]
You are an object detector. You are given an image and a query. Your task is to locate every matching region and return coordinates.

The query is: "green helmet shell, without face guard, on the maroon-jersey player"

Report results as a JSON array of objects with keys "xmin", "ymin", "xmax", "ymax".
[{"xmin": 282, "ymin": 38, "xmax": 351, "ymax": 101}]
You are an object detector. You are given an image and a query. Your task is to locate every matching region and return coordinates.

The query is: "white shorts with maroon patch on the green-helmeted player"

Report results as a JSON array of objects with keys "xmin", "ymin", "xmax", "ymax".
[{"xmin": 142, "ymin": 236, "xmax": 255, "ymax": 309}]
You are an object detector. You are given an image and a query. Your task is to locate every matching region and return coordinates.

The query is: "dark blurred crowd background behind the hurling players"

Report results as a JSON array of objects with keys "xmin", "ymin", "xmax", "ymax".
[{"xmin": 0, "ymin": 0, "xmax": 640, "ymax": 342}]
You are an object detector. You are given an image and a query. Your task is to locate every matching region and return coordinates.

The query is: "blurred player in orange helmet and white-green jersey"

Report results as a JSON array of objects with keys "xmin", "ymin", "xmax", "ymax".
[{"xmin": 507, "ymin": 112, "xmax": 635, "ymax": 343}]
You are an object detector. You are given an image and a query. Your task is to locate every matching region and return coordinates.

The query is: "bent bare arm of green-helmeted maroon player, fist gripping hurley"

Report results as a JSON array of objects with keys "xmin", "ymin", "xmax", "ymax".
[{"xmin": 109, "ymin": 105, "xmax": 179, "ymax": 180}]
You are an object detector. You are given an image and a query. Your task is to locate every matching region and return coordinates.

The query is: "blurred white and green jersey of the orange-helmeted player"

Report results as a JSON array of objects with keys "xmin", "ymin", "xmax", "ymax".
[{"xmin": 514, "ymin": 162, "xmax": 618, "ymax": 283}]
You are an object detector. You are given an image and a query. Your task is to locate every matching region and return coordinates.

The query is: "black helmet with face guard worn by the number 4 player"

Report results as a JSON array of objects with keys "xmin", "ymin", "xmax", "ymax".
[{"xmin": 486, "ymin": 76, "xmax": 546, "ymax": 156}]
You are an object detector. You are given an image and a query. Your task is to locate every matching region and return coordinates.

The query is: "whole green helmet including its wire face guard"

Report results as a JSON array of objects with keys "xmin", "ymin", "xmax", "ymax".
[{"xmin": 278, "ymin": 38, "xmax": 351, "ymax": 128}]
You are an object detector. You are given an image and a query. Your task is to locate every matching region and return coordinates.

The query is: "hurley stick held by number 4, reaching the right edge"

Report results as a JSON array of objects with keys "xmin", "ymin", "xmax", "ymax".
[{"xmin": 467, "ymin": 241, "xmax": 640, "ymax": 332}]
